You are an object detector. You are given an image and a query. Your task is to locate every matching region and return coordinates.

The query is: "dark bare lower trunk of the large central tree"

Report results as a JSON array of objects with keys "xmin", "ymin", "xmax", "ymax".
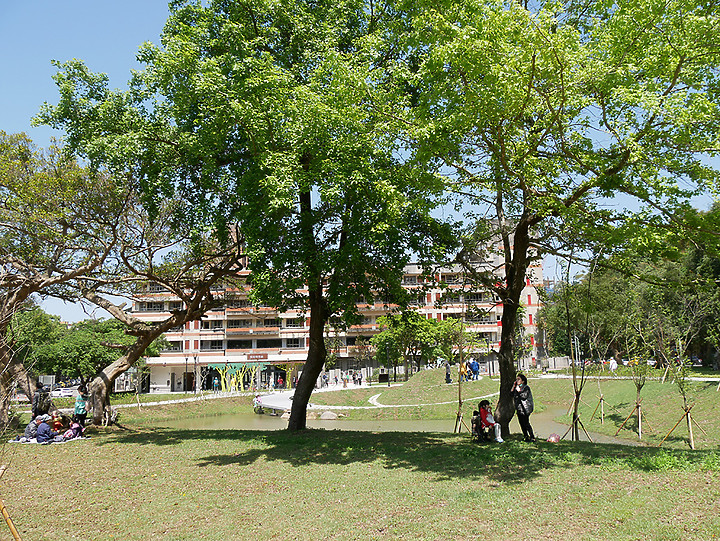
[{"xmin": 288, "ymin": 285, "xmax": 327, "ymax": 432}]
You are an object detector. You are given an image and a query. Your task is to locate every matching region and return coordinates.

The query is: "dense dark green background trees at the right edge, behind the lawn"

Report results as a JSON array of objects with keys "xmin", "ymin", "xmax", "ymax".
[{"xmin": 539, "ymin": 243, "xmax": 720, "ymax": 366}]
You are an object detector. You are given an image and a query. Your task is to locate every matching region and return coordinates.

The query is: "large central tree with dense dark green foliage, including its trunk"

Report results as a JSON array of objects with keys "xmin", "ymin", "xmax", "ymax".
[{"xmin": 40, "ymin": 0, "xmax": 449, "ymax": 430}]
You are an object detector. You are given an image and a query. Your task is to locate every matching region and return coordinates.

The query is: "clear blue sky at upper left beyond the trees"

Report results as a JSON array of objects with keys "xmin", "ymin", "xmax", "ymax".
[{"xmin": 0, "ymin": 0, "xmax": 168, "ymax": 321}]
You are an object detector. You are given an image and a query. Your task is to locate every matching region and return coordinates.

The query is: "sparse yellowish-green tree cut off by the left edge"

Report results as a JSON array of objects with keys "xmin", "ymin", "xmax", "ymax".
[{"xmin": 0, "ymin": 132, "xmax": 125, "ymax": 425}]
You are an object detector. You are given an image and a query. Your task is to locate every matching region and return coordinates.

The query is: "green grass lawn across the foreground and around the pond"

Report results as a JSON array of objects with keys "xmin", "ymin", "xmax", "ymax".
[{"xmin": 0, "ymin": 372, "xmax": 720, "ymax": 541}]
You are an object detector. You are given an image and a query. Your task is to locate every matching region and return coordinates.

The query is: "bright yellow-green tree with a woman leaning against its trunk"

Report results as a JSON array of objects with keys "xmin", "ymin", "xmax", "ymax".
[{"xmin": 388, "ymin": 0, "xmax": 720, "ymax": 432}]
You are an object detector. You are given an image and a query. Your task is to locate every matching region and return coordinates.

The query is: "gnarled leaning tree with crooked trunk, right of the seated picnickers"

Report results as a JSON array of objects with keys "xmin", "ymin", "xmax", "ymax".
[{"xmin": 77, "ymin": 198, "xmax": 245, "ymax": 424}]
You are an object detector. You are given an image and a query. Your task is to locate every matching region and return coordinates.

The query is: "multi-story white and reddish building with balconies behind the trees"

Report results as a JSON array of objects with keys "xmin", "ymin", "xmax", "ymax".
[{"xmin": 132, "ymin": 262, "xmax": 543, "ymax": 393}]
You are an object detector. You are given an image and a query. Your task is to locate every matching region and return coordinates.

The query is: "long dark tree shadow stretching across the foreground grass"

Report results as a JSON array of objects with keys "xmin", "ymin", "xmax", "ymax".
[{"xmin": 97, "ymin": 428, "xmax": 720, "ymax": 483}]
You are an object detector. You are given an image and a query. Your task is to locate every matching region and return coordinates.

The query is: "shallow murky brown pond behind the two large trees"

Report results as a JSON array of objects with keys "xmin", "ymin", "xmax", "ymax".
[{"xmin": 163, "ymin": 407, "xmax": 627, "ymax": 444}]
